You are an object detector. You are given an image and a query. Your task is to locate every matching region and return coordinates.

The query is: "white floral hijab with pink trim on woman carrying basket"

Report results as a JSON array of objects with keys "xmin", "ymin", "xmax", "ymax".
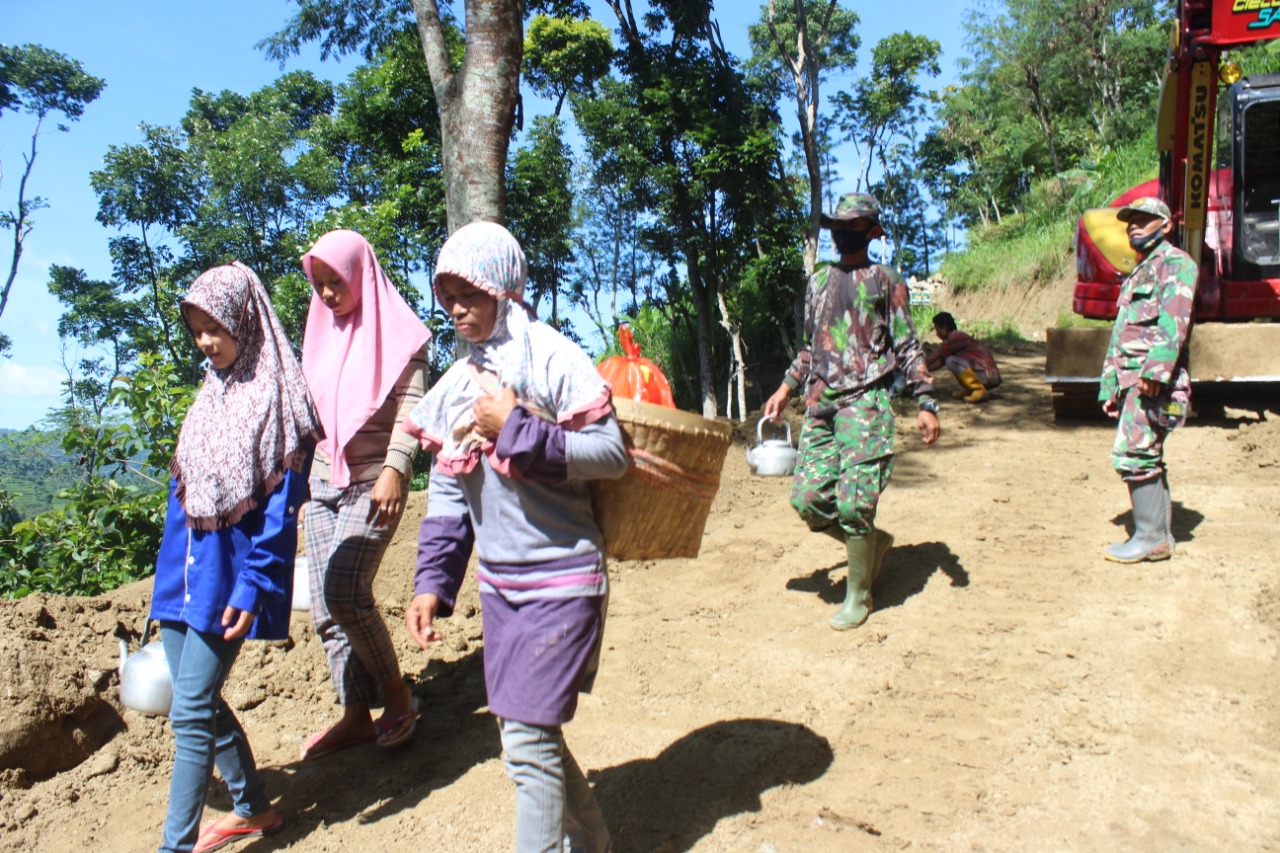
[{"xmin": 403, "ymin": 222, "xmax": 613, "ymax": 475}]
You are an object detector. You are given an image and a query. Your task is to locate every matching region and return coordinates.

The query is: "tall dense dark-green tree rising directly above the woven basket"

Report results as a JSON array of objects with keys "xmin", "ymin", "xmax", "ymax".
[{"xmin": 586, "ymin": 0, "xmax": 795, "ymax": 415}]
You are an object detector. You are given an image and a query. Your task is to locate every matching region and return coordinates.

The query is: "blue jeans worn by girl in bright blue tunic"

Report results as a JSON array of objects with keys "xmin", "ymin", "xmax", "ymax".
[{"xmin": 160, "ymin": 621, "xmax": 271, "ymax": 853}]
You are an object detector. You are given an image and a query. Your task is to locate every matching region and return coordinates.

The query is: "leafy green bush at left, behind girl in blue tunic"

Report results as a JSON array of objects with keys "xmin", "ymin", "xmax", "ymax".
[{"xmin": 0, "ymin": 355, "xmax": 195, "ymax": 598}]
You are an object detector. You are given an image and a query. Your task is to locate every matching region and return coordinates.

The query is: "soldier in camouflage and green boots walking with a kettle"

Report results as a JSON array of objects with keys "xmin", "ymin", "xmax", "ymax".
[{"xmin": 764, "ymin": 193, "xmax": 941, "ymax": 630}]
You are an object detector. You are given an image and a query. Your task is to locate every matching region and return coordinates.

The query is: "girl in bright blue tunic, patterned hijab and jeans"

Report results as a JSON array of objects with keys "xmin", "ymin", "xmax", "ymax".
[{"xmin": 151, "ymin": 263, "xmax": 323, "ymax": 853}]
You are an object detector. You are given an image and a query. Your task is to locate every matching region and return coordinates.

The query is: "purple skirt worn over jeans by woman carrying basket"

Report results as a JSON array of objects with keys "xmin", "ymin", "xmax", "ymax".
[{"xmin": 480, "ymin": 593, "xmax": 605, "ymax": 726}]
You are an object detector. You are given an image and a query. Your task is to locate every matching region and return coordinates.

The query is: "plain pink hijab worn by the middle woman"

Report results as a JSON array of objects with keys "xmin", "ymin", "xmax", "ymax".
[{"xmin": 302, "ymin": 231, "xmax": 431, "ymax": 488}]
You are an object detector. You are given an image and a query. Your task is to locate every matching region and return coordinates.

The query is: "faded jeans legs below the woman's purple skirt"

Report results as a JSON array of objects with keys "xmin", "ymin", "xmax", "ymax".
[{"xmin": 499, "ymin": 720, "xmax": 611, "ymax": 853}]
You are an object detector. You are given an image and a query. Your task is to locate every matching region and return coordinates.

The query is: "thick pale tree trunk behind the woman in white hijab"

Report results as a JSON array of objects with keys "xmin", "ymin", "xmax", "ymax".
[{"xmin": 412, "ymin": 0, "xmax": 525, "ymax": 233}]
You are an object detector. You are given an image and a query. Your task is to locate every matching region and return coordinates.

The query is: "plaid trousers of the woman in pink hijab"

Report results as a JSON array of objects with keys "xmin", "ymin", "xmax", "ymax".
[{"xmin": 303, "ymin": 478, "xmax": 401, "ymax": 707}]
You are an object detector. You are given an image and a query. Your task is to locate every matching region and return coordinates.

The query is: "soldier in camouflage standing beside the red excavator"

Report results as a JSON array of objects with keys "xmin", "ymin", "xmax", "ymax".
[{"xmin": 1098, "ymin": 197, "xmax": 1199, "ymax": 562}]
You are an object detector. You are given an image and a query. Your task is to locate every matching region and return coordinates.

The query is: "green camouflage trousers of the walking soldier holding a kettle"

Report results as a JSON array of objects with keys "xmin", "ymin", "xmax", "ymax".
[{"xmin": 791, "ymin": 388, "xmax": 893, "ymax": 537}]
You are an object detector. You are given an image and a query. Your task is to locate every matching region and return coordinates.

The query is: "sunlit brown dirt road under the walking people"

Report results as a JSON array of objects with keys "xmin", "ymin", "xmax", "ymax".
[{"xmin": 0, "ymin": 345, "xmax": 1280, "ymax": 853}]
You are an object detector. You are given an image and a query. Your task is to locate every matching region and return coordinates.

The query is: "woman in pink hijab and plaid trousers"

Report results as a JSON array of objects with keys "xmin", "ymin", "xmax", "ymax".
[{"xmin": 302, "ymin": 231, "xmax": 431, "ymax": 760}]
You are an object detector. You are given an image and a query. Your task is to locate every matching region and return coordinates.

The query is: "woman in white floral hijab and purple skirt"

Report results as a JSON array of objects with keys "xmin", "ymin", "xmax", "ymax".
[{"xmin": 406, "ymin": 222, "xmax": 627, "ymax": 853}]
